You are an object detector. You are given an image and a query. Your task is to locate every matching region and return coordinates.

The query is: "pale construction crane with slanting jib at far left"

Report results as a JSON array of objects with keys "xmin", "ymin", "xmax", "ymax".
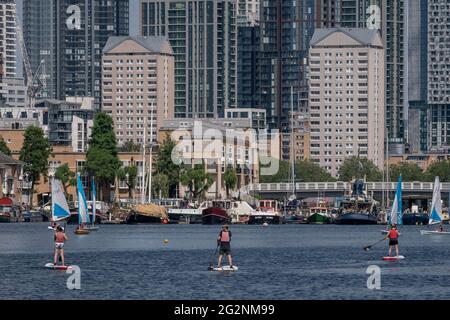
[{"xmin": 15, "ymin": 14, "xmax": 47, "ymax": 108}]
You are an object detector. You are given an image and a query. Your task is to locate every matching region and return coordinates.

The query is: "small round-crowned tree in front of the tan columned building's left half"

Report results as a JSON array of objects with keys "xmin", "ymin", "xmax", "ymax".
[{"xmin": 181, "ymin": 164, "xmax": 214, "ymax": 200}]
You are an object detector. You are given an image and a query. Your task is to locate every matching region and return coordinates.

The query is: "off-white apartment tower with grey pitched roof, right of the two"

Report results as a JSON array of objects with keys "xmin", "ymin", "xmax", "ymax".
[{"xmin": 309, "ymin": 28, "xmax": 386, "ymax": 177}]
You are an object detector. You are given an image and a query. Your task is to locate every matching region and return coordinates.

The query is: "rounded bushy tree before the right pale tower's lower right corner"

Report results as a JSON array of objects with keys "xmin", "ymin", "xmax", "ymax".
[{"xmin": 338, "ymin": 157, "xmax": 383, "ymax": 182}]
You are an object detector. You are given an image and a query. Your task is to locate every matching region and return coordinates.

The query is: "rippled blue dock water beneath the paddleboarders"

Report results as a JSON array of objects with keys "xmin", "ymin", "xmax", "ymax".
[{"xmin": 0, "ymin": 224, "xmax": 450, "ymax": 299}]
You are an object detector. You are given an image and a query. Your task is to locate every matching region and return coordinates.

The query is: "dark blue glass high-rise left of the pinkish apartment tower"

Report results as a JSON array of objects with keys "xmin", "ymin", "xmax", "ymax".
[{"xmin": 23, "ymin": 0, "xmax": 129, "ymax": 108}]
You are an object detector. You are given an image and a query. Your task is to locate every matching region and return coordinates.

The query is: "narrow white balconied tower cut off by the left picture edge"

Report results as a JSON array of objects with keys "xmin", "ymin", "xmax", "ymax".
[{"xmin": 0, "ymin": 0, "xmax": 16, "ymax": 78}]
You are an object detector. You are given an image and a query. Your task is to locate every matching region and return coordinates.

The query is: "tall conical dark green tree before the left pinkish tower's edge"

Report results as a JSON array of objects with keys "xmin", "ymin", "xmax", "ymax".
[{"xmin": 86, "ymin": 112, "xmax": 120, "ymax": 200}]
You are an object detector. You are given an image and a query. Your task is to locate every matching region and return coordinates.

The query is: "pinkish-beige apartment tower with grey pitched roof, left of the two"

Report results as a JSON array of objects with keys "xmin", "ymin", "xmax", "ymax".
[{"xmin": 102, "ymin": 36, "xmax": 175, "ymax": 145}]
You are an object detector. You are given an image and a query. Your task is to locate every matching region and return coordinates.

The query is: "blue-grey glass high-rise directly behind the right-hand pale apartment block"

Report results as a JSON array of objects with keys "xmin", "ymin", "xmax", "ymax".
[{"xmin": 340, "ymin": 0, "xmax": 408, "ymax": 155}]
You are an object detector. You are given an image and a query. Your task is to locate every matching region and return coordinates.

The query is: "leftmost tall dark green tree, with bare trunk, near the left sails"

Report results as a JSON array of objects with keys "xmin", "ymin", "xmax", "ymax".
[{"xmin": 19, "ymin": 126, "xmax": 52, "ymax": 206}]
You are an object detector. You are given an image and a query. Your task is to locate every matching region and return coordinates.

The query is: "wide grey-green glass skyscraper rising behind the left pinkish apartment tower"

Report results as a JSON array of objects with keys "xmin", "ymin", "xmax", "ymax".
[{"xmin": 141, "ymin": 0, "xmax": 237, "ymax": 118}]
